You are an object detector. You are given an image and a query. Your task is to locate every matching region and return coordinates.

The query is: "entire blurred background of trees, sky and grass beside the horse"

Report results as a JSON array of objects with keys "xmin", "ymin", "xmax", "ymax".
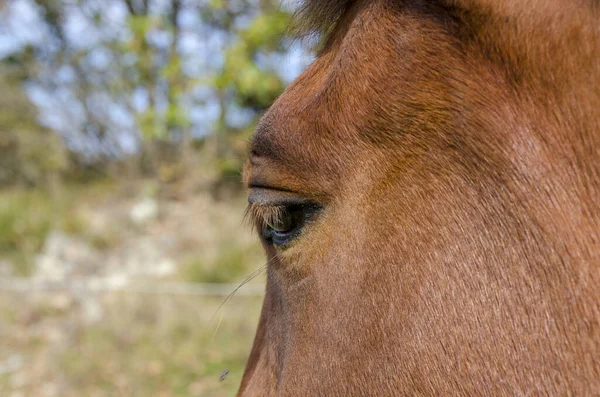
[{"xmin": 0, "ymin": 0, "xmax": 312, "ymax": 397}]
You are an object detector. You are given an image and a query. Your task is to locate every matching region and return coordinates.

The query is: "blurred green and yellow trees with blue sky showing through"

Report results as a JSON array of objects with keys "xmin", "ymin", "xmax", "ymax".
[{"xmin": 0, "ymin": 0, "xmax": 298, "ymax": 189}]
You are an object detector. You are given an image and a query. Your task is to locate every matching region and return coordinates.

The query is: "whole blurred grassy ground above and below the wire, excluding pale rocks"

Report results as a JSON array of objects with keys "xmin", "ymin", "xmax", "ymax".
[{"xmin": 0, "ymin": 182, "xmax": 264, "ymax": 397}]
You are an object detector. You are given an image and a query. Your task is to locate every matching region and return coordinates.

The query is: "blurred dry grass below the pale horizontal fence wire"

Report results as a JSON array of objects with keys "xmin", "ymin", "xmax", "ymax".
[{"xmin": 0, "ymin": 293, "xmax": 261, "ymax": 397}]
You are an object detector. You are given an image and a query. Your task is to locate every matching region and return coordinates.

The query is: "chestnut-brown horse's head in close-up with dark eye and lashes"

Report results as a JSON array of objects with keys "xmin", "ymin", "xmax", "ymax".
[{"xmin": 237, "ymin": 0, "xmax": 600, "ymax": 397}]
